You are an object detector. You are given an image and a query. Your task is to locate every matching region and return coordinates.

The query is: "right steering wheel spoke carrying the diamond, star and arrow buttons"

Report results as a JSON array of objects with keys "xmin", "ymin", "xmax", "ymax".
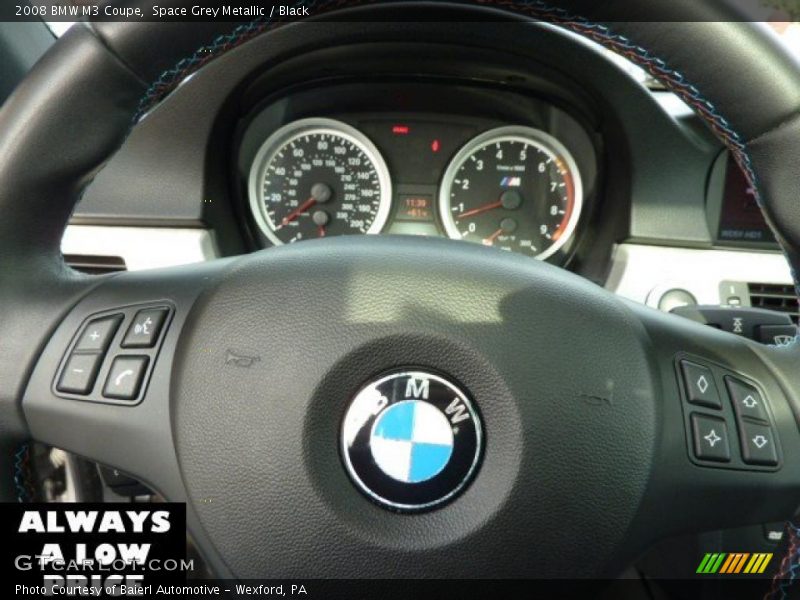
[{"xmin": 635, "ymin": 307, "xmax": 800, "ymax": 534}]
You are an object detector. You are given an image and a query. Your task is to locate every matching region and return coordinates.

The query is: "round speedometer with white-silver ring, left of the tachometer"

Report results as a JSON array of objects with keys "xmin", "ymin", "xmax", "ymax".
[{"xmin": 249, "ymin": 118, "xmax": 391, "ymax": 244}]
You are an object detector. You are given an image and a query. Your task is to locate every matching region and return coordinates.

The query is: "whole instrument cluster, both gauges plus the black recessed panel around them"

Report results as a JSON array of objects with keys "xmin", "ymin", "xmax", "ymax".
[{"xmin": 237, "ymin": 82, "xmax": 598, "ymax": 263}]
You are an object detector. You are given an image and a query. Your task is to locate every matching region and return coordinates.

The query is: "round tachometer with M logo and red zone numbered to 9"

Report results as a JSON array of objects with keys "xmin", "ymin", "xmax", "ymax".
[{"xmin": 439, "ymin": 126, "xmax": 583, "ymax": 259}]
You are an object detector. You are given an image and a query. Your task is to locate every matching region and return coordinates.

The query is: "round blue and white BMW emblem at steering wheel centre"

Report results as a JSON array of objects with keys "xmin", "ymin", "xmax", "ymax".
[{"xmin": 342, "ymin": 371, "xmax": 483, "ymax": 511}]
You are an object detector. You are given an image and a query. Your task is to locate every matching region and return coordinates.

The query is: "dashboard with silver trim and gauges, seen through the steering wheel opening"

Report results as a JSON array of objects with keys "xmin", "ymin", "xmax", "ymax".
[{"xmin": 57, "ymin": 22, "xmax": 791, "ymax": 316}]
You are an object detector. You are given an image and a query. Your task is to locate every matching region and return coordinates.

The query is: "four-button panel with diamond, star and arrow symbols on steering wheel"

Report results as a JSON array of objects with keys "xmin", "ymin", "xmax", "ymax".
[{"xmin": 676, "ymin": 356, "xmax": 781, "ymax": 471}]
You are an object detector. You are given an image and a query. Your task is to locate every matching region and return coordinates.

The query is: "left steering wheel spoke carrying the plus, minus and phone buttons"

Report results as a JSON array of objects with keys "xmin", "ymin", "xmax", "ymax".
[{"xmin": 22, "ymin": 261, "xmax": 227, "ymax": 501}]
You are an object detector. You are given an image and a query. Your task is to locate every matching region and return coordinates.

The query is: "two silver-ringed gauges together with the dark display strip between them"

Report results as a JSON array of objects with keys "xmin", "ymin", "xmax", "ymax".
[{"xmin": 249, "ymin": 118, "xmax": 584, "ymax": 259}]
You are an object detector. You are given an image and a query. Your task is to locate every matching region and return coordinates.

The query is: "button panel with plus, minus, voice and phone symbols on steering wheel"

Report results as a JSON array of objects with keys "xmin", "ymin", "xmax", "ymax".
[{"xmin": 53, "ymin": 304, "xmax": 173, "ymax": 405}]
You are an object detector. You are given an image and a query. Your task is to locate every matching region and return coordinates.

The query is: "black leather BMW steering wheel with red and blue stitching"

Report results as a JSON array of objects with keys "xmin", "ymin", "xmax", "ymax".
[{"xmin": 0, "ymin": 0, "xmax": 800, "ymax": 578}]
